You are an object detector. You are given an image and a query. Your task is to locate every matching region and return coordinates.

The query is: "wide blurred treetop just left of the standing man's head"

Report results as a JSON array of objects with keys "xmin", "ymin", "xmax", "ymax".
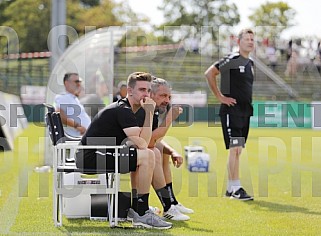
[{"xmin": 159, "ymin": 0, "xmax": 240, "ymax": 40}]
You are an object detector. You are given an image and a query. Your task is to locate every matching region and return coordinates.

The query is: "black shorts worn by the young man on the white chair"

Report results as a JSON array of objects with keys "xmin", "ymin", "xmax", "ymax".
[{"xmin": 76, "ymin": 147, "xmax": 137, "ymax": 173}]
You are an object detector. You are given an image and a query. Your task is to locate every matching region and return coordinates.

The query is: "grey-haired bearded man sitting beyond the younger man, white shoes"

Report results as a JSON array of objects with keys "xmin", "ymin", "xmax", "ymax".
[{"xmin": 135, "ymin": 78, "xmax": 194, "ymax": 221}]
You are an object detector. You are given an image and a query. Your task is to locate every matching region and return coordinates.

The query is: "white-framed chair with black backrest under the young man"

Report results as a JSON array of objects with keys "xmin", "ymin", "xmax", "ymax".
[{"xmin": 44, "ymin": 104, "xmax": 123, "ymax": 227}]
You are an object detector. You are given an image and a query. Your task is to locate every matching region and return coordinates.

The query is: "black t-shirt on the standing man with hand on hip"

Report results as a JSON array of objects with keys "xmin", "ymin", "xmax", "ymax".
[{"xmin": 214, "ymin": 53, "xmax": 254, "ymax": 116}]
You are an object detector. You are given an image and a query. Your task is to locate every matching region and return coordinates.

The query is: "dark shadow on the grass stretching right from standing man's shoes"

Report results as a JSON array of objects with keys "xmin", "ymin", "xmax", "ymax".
[{"xmin": 246, "ymin": 201, "xmax": 321, "ymax": 216}]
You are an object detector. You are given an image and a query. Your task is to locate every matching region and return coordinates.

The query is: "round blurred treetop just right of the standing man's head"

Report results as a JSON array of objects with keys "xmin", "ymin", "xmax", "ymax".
[{"xmin": 249, "ymin": 2, "xmax": 296, "ymax": 41}]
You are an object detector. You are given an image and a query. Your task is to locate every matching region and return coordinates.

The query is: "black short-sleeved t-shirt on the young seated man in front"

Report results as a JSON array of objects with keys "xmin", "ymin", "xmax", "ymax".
[{"xmin": 81, "ymin": 98, "xmax": 138, "ymax": 148}]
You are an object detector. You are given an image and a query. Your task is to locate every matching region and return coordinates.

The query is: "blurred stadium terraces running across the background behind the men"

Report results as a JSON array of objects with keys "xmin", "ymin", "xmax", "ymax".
[{"xmin": 0, "ymin": 49, "xmax": 321, "ymax": 103}]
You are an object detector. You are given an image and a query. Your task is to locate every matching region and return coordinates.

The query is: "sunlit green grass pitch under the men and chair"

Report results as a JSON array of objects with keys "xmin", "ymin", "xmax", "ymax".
[{"xmin": 0, "ymin": 123, "xmax": 321, "ymax": 235}]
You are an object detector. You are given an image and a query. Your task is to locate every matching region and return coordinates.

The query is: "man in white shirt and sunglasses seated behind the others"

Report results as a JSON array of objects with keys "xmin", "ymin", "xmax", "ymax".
[{"xmin": 55, "ymin": 73, "xmax": 91, "ymax": 137}]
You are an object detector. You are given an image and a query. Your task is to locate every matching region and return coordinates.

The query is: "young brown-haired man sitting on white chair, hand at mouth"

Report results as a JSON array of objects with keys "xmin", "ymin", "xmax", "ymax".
[{"xmin": 76, "ymin": 72, "xmax": 172, "ymax": 229}]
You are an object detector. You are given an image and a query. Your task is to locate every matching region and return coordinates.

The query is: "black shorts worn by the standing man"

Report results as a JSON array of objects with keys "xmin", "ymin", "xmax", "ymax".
[{"xmin": 220, "ymin": 114, "xmax": 250, "ymax": 149}]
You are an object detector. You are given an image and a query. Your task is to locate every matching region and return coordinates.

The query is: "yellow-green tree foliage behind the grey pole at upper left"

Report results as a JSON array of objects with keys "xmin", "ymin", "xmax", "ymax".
[{"xmin": 0, "ymin": 0, "xmax": 140, "ymax": 54}]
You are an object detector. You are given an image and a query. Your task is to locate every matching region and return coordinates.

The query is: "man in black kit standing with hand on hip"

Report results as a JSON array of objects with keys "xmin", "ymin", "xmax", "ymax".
[{"xmin": 205, "ymin": 29, "xmax": 254, "ymax": 201}]
